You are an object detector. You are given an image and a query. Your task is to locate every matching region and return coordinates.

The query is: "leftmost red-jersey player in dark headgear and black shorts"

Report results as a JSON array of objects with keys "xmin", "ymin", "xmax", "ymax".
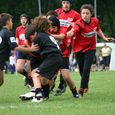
[{"xmin": 16, "ymin": 14, "xmax": 32, "ymax": 85}]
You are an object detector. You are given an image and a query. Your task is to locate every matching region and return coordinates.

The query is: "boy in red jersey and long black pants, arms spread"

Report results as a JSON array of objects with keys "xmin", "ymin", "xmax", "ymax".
[{"xmin": 67, "ymin": 4, "xmax": 113, "ymax": 96}]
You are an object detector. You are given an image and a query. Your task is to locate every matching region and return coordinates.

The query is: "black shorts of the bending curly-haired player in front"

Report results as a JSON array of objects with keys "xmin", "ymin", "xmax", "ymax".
[{"xmin": 36, "ymin": 54, "xmax": 62, "ymax": 80}]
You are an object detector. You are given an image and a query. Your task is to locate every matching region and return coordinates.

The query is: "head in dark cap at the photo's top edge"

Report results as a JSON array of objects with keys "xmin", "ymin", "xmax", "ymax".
[{"xmin": 62, "ymin": 0, "xmax": 72, "ymax": 12}]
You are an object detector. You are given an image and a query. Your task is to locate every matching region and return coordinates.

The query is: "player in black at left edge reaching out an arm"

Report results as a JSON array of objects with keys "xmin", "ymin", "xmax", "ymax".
[{"xmin": 0, "ymin": 13, "xmax": 38, "ymax": 86}]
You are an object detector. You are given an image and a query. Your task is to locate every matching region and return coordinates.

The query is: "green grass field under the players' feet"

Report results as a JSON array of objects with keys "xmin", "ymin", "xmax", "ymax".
[{"xmin": 0, "ymin": 72, "xmax": 115, "ymax": 115}]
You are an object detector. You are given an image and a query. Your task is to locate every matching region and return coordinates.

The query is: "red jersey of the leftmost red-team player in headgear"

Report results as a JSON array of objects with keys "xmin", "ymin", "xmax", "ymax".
[{"xmin": 16, "ymin": 25, "xmax": 25, "ymax": 45}]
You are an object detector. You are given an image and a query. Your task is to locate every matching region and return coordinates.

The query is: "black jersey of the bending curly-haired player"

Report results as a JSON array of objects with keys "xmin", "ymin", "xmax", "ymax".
[{"xmin": 33, "ymin": 33, "xmax": 61, "ymax": 57}]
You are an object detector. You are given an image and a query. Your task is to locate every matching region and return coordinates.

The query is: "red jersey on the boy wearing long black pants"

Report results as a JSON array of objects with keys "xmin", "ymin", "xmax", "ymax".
[{"xmin": 72, "ymin": 17, "xmax": 100, "ymax": 52}]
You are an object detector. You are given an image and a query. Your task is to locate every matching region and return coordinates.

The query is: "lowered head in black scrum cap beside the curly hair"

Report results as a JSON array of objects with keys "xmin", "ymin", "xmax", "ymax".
[{"xmin": 49, "ymin": 16, "xmax": 60, "ymax": 34}]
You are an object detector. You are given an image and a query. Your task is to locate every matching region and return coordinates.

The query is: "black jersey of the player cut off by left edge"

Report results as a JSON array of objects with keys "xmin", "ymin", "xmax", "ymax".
[{"xmin": 0, "ymin": 28, "xmax": 17, "ymax": 60}]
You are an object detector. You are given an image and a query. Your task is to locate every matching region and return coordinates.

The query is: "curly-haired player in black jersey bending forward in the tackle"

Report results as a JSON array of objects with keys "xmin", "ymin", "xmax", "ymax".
[{"xmin": 24, "ymin": 16, "xmax": 62, "ymax": 102}]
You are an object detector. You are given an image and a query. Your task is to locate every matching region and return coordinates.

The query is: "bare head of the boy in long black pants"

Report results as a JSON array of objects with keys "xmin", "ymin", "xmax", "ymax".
[{"xmin": 80, "ymin": 4, "xmax": 93, "ymax": 23}]
